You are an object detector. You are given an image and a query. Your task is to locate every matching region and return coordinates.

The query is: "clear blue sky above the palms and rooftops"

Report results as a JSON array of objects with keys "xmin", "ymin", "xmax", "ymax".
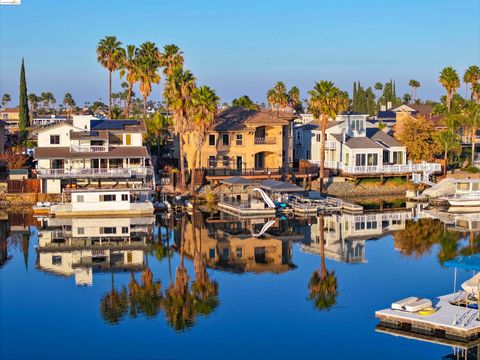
[{"xmin": 0, "ymin": 0, "xmax": 480, "ymax": 105}]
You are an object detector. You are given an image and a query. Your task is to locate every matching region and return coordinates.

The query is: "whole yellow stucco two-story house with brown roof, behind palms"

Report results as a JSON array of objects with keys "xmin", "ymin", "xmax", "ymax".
[{"xmin": 184, "ymin": 106, "xmax": 295, "ymax": 170}]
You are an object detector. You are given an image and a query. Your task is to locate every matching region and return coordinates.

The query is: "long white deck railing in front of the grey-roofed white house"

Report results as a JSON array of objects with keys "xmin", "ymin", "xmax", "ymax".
[{"xmin": 310, "ymin": 160, "xmax": 442, "ymax": 174}]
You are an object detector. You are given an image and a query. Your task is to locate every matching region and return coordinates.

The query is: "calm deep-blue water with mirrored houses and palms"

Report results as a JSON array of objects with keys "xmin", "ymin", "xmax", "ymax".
[{"xmin": 0, "ymin": 210, "xmax": 480, "ymax": 359}]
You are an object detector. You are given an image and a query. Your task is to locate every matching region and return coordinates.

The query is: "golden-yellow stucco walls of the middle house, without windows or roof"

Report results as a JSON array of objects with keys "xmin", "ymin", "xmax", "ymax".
[{"xmin": 184, "ymin": 126, "xmax": 284, "ymax": 169}]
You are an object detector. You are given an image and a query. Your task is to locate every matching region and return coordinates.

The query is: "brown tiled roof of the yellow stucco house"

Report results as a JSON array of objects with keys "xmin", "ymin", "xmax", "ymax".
[{"xmin": 211, "ymin": 106, "xmax": 293, "ymax": 131}]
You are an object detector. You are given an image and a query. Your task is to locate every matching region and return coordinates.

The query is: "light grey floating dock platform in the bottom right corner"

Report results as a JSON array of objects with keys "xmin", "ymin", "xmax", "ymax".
[{"xmin": 375, "ymin": 294, "xmax": 480, "ymax": 343}]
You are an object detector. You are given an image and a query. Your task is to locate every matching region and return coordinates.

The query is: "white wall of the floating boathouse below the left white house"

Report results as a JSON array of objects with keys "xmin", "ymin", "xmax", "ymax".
[{"xmin": 72, "ymin": 191, "xmax": 130, "ymax": 211}]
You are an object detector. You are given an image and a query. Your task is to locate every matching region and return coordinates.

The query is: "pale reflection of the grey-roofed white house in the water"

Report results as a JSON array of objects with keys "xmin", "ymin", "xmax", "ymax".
[{"xmin": 302, "ymin": 210, "xmax": 412, "ymax": 263}]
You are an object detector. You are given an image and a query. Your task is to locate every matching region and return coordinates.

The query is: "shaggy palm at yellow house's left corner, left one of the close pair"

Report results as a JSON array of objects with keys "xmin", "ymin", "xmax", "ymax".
[{"xmin": 163, "ymin": 68, "xmax": 195, "ymax": 190}]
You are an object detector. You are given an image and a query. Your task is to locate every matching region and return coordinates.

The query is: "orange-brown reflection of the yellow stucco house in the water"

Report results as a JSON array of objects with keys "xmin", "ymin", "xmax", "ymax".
[{"xmin": 175, "ymin": 212, "xmax": 295, "ymax": 274}]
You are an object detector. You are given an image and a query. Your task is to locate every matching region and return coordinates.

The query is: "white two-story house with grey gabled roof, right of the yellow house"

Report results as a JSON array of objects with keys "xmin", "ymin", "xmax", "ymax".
[{"xmin": 294, "ymin": 112, "xmax": 441, "ymax": 176}]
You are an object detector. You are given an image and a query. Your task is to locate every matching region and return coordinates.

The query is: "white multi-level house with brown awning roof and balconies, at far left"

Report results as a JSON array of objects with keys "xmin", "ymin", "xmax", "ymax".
[{"xmin": 35, "ymin": 115, "xmax": 153, "ymax": 194}]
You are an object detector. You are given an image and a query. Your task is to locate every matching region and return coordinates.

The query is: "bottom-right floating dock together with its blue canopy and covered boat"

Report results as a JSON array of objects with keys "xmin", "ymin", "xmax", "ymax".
[{"xmin": 375, "ymin": 253, "xmax": 480, "ymax": 342}]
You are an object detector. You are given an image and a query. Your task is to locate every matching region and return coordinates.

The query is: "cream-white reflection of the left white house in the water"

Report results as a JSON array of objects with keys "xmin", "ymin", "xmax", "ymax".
[{"xmin": 37, "ymin": 216, "xmax": 155, "ymax": 285}]
